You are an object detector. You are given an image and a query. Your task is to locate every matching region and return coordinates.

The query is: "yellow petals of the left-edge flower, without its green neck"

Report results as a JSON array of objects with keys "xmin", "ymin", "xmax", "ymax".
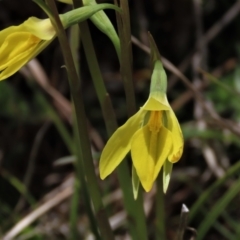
[{"xmin": 0, "ymin": 17, "xmax": 56, "ymax": 80}]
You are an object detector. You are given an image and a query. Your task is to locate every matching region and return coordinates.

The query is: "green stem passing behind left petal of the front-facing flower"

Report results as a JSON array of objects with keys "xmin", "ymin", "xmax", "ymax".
[{"xmin": 74, "ymin": 6, "xmax": 147, "ymax": 240}]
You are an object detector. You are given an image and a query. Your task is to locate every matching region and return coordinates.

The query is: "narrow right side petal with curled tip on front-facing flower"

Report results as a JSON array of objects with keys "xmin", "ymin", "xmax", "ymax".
[{"xmin": 166, "ymin": 110, "xmax": 184, "ymax": 163}]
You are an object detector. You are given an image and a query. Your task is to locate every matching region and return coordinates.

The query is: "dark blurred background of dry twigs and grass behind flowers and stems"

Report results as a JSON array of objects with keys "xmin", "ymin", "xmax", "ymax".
[{"xmin": 0, "ymin": 0, "xmax": 240, "ymax": 240}]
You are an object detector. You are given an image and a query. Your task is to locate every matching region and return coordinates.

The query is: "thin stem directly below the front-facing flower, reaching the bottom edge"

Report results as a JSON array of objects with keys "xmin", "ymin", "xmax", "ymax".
[{"xmin": 155, "ymin": 170, "xmax": 166, "ymax": 240}]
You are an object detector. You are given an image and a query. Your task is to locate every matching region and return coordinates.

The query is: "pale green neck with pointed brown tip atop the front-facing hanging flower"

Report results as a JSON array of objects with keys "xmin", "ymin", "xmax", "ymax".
[{"xmin": 148, "ymin": 33, "xmax": 167, "ymax": 95}]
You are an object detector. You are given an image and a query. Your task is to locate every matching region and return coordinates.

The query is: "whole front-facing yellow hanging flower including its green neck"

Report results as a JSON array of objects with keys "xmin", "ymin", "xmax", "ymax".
[{"xmin": 100, "ymin": 35, "xmax": 183, "ymax": 193}]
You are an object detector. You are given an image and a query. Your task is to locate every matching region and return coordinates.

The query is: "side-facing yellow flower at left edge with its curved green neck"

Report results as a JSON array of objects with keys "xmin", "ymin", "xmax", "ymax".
[{"xmin": 0, "ymin": 4, "xmax": 118, "ymax": 80}]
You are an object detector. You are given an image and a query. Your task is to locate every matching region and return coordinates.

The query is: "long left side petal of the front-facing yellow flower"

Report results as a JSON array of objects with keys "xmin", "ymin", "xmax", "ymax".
[{"xmin": 99, "ymin": 109, "xmax": 146, "ymax": 179}]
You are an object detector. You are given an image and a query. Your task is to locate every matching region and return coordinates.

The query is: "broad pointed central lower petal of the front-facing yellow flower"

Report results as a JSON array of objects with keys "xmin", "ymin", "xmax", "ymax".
[{"xmin": 131, "ymin": 125, "xmax": 172, "ymax": 192}]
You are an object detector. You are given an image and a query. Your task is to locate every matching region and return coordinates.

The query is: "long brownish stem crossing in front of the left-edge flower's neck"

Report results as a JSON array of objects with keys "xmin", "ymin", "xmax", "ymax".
[{"xmin": 46, "ymin": 0, "xmax": 114, "ymax": 240}]
